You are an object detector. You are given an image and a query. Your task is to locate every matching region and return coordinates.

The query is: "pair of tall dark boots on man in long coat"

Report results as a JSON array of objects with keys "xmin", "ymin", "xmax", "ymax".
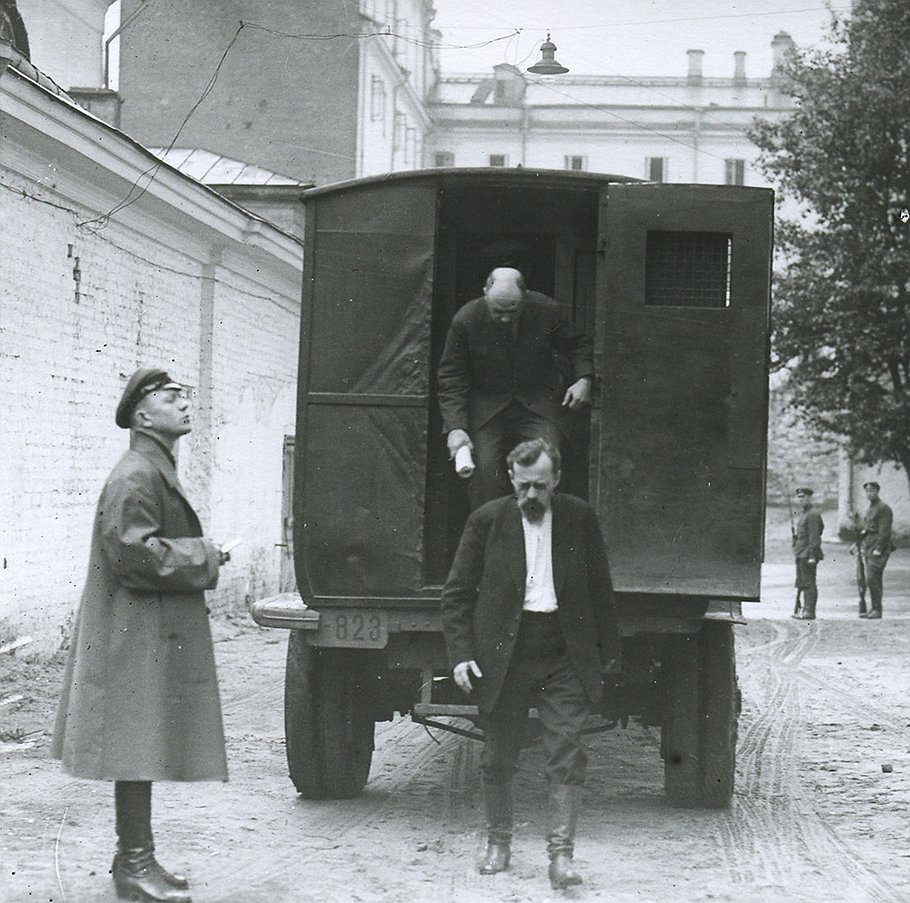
[{"xmin": 111, "ymin": 781, "xmax": 191, "ymax": 903}]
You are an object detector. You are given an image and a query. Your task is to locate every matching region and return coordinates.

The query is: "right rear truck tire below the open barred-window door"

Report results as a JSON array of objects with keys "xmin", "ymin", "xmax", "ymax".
[{"xmin": 661, "ymin": 622, "xmax": 739, "ymax": 809}]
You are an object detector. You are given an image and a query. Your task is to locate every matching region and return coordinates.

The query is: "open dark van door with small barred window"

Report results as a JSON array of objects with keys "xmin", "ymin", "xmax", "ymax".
[{"xmin": 590, "ymin": 184, "xmax": 773, "ymax": 600}]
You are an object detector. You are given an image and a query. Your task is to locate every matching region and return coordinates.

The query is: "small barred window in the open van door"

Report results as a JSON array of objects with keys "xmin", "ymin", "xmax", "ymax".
[{"xmin": 645, "ymin": 230, "xmax": 733, "ymax": 307}]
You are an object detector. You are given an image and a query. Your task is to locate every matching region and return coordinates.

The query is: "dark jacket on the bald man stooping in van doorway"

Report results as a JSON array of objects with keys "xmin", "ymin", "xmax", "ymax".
[{"xmin": 438, "ymin": 292, "xmax": 594, "ymax": 433}]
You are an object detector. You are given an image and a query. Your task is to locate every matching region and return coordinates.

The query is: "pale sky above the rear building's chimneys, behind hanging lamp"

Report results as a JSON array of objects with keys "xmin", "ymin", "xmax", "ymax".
[{"xmin": 434, "ymin": 0, "xmax": 850, "ymax": 78}]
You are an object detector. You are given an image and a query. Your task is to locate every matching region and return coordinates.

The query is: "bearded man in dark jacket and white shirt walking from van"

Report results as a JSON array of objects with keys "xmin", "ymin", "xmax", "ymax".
[{"xmin": 442, "ymin": 439, "xmax": 620, "ymax": 888}]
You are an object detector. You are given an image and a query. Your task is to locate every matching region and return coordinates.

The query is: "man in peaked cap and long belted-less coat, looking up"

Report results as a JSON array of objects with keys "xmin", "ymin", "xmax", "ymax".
[{"xmin": 52, "ymin": 368, "xmax": 228, "ymax": 903}]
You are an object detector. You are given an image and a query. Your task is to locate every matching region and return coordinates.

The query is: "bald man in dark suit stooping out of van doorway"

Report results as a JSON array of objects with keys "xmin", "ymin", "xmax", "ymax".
[{"xmin": 437, "ymin": 267, "xmax": 594, "ymax": 508}]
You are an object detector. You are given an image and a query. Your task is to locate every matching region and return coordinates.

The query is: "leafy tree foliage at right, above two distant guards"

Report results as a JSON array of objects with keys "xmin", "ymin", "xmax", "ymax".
[{"xmin": 752, "ymin": 0, "xmax": 910, "ymax": 478}]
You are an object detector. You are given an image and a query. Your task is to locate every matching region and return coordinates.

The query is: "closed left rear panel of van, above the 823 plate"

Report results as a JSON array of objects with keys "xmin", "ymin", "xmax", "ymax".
[{"xmin": 294, "ymin": 180, "xmax": 436, "ymax": 607}]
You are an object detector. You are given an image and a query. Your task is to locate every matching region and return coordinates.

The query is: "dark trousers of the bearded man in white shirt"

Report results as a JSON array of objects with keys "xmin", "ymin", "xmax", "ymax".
[{"xmin": 481, "ymin": 612, "xmax": 594, "ymax": 786}]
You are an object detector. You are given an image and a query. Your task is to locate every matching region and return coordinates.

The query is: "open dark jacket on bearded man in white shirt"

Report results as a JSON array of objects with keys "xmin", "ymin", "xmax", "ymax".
[{"xmin": 442, "ymin": 494, "xmax": 620, "ymax": 711}]
